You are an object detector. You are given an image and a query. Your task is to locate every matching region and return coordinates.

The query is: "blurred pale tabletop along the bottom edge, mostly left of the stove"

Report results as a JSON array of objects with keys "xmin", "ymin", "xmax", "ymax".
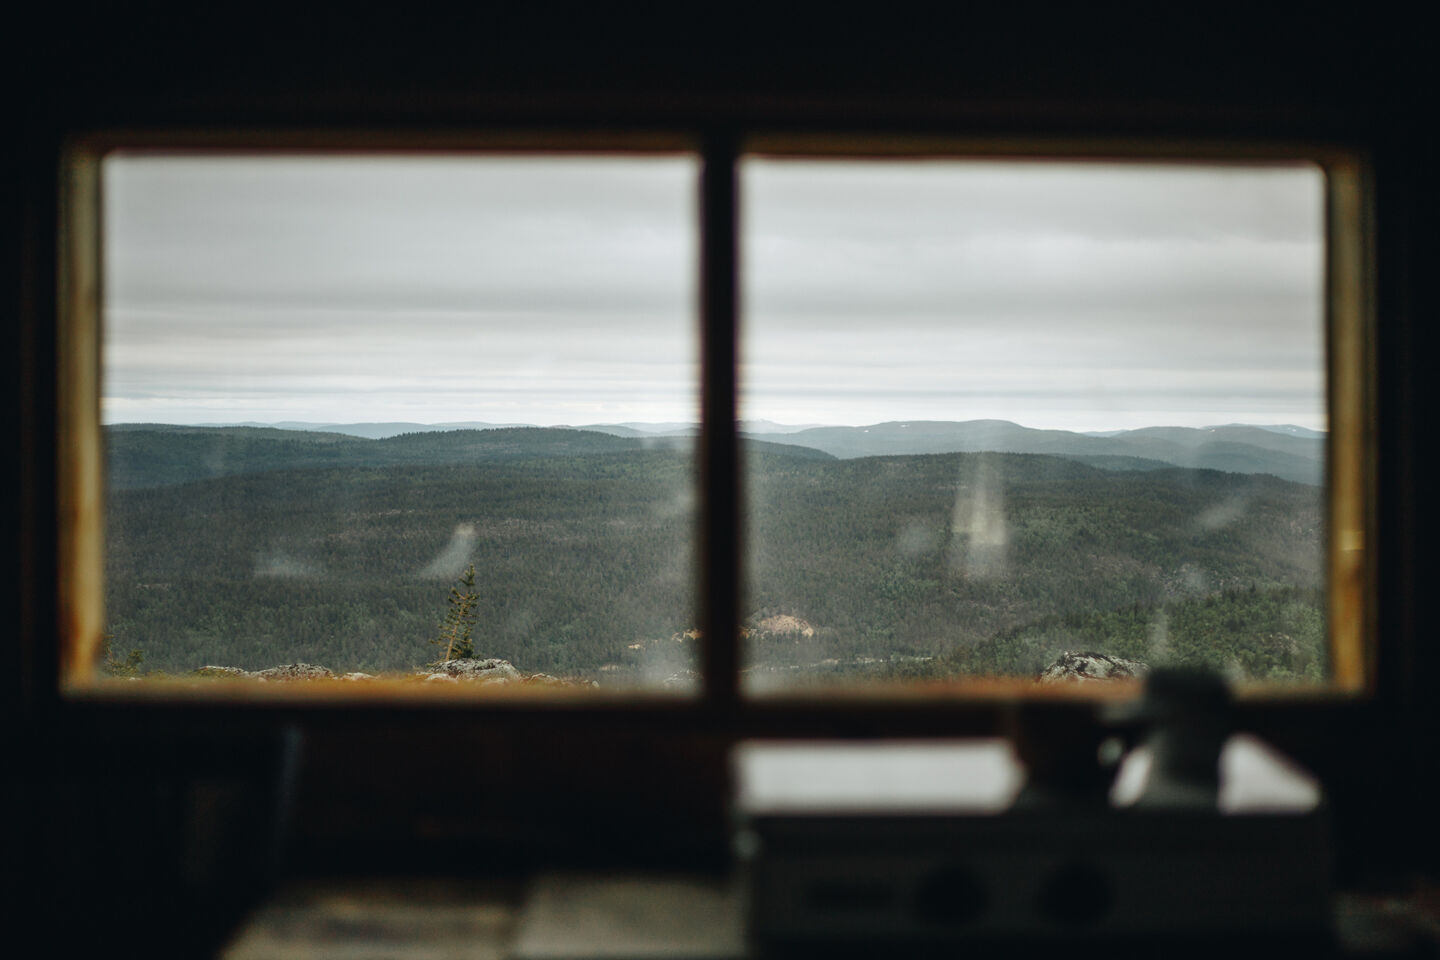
[{"xmin": 219, "ymin": 874, "xmax": 1440, "ymax": 960}]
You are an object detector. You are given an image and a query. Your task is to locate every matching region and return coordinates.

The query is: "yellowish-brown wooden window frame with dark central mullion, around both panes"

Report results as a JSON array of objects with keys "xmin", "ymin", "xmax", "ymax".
[{"xmin": 58, "ymin": 131, "xmax": 1375, "ymax": 714}]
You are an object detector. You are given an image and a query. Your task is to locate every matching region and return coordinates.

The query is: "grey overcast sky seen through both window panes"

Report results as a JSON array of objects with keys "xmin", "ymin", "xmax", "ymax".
[{"xmin": 104, "ymin": 155, "xmax": 1325, "ymax": 429}]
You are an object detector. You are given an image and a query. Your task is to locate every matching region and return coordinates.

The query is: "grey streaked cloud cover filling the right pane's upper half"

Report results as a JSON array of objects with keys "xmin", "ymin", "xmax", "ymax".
[{"xmin": 743, "ymin": 161, "xmax": 1325, "ymax": 429}]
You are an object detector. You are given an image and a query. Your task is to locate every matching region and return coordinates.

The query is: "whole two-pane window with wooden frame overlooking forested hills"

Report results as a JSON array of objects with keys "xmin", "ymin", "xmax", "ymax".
[{"xmin": 62, "ymin": 138, "xmax": 1371, "ymax": 702}]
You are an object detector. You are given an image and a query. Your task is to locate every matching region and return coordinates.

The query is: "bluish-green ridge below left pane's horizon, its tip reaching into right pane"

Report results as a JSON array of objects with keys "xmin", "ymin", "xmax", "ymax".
[{"xmin": 105, "ymin": 423, "xmax": 831, "ymax": 491}]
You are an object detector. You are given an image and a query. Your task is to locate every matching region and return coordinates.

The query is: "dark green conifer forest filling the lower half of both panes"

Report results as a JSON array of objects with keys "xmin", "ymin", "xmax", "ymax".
[{"xmin": 107, "ymin": 426, "xmax": 1325, "ymax": 685}]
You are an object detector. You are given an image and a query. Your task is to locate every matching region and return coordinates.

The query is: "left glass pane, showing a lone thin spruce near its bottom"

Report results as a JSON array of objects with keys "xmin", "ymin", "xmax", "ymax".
[{"xmin": 102, "ymin": 154, "xmax": 698, "ymax": 691}]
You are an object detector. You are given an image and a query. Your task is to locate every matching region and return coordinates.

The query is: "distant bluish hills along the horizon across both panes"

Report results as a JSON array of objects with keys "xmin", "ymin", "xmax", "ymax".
[{"xmin": 107, "ymin": 420, "xmax": 1325, "ymax": 489}]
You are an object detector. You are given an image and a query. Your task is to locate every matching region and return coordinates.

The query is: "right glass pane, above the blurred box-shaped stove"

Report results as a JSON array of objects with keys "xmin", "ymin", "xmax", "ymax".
[{"xmin": 742, "ymin": 157, "xmax": 1328, "ymax": 692}]
